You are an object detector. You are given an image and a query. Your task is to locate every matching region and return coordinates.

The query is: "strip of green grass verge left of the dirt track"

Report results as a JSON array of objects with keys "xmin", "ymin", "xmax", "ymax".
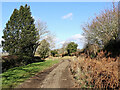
[{"xmin": 0, "ymin": 60, "xmax": 59, "ymax": 88}]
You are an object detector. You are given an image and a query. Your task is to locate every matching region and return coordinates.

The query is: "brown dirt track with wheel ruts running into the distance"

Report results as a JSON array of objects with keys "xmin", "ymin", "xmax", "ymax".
[{"xmin": 17, "ymin": 60, "xmax": 74, "ymax": 88}]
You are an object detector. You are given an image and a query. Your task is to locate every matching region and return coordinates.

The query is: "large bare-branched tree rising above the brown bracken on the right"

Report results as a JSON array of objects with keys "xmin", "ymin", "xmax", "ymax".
[{"xmin": 83, "ymin": 3, "xmax": 118, "ymax": 48}]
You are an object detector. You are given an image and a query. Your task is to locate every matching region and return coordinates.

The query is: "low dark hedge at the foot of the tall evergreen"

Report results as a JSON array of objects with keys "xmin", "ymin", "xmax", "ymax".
[{"xmin": 2, "ymin": 55, "xmax": 34, "ymax": 72}]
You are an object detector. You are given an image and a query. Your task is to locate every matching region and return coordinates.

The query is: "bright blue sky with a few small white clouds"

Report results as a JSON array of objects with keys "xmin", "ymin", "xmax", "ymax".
[{"xmin": 0, "ymin": 2, "xmax": 112, "ymax": 51}]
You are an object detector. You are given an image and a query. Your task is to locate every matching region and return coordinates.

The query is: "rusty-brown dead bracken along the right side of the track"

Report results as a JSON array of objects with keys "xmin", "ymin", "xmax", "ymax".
[{"xmin": 71, "ymin": 51, "xmax": 120, "ymax": 88}]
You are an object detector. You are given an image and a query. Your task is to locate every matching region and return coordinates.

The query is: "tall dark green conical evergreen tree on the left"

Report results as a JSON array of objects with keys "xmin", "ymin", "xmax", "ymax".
[{"xmin": 2, "ymin": 4, "xmax": 38, "ymax": 56}]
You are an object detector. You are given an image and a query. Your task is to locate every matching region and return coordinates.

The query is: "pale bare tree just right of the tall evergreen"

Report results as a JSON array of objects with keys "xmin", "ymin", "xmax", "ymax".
[{"xmin": 35, "ymin": 20, "xmax": 55, "ymax": 53}]
